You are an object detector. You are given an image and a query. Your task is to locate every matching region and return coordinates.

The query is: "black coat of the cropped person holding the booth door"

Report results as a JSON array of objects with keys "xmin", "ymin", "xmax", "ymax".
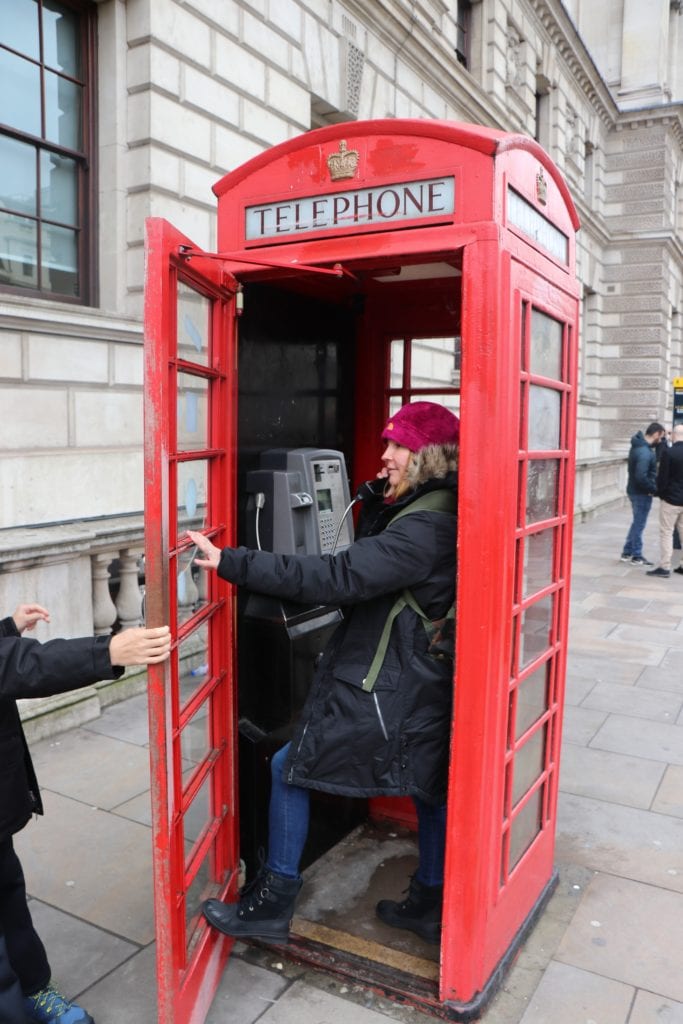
[{"xmin": 0, "ymin": 617, "xmax": 123, "ymax": 843}]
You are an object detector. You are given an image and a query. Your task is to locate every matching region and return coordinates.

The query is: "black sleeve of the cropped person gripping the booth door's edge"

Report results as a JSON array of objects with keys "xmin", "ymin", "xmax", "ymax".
[{"xmin": 0, "ymin": 620, "xmax": 124, "ymax": 700}]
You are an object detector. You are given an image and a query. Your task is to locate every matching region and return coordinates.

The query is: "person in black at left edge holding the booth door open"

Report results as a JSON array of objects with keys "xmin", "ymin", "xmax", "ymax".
[{"xmin": 0, "ymin": 604, "xmax": 170, "ymax": 1024}]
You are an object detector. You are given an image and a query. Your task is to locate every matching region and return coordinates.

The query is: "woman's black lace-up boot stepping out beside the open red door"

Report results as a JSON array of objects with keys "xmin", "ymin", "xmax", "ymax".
[{"xmin": 202, "ymin": 868, "xmax": 302, "ymax": 939}]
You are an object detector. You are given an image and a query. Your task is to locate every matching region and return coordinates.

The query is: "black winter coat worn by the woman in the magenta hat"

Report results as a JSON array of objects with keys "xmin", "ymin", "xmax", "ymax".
[{"xmin": 218, "ymin": 474, "xmax": 456, "ymax": 804}]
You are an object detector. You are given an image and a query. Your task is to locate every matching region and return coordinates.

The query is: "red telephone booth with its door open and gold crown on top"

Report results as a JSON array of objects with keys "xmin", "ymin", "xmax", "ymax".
[{"xmin": 145, "ymin": 120, "xmax": 579, "ymax": 1024}]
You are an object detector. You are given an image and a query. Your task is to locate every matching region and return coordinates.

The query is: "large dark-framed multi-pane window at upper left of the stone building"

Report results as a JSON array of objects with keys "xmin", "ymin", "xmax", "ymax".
[{"xmin": 0, "ymin": 0, "xmax": 95, "ymax": 302}]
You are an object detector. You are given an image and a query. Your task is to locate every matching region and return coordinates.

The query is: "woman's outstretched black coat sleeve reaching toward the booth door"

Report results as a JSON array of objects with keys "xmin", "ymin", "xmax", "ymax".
[{"xmin": 218, "ymin": 512, "xmax": 446, "ymax": 604}]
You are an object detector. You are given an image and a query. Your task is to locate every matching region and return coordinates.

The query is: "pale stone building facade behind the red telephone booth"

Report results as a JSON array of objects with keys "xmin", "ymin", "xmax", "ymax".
[{"xmin": 0, "ymin": 0, "xmax": 683, "ymax": 704}]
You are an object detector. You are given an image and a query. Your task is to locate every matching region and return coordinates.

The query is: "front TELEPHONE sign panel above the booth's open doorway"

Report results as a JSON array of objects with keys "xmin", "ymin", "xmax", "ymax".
[{"xmin": 245, "ymin": 177, "xmax": 456, "ymax": 241}]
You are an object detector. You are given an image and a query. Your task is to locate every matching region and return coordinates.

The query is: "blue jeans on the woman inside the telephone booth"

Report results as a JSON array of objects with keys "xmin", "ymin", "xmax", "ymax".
[{"xmin": 266, "ymin": 743, "xmax": 445, "ymax": 886}]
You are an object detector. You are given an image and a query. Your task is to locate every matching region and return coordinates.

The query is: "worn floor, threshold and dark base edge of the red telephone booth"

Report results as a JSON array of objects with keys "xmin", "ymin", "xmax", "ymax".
[{"xmin": 245, "ymin": 823, "xmax": 558, "ymax": 1021}]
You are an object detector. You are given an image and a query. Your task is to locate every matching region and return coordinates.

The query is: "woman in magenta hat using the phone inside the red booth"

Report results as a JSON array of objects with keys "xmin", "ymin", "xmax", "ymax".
[{"xmin": 189, "ymin": 401, "xmax": 460, "ymax": 942}]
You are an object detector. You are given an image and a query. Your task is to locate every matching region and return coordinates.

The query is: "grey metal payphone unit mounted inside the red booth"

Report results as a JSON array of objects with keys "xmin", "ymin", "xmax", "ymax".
[{"xmin": 247, "ymin": 447, "xmax": 353, "ymax": 555}]
